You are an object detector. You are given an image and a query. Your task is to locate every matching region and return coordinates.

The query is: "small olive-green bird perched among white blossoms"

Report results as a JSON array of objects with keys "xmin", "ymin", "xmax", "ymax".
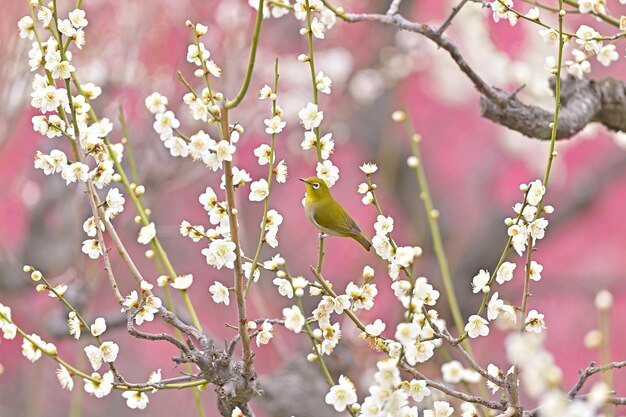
[{"xmin": 300, "ymin": 177, "xmax": 372, "ymax": 251}]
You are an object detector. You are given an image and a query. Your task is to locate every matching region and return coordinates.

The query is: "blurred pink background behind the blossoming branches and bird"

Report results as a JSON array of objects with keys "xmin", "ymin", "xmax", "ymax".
[{"xmin": 0, "ymin": 0, "xmax": 626, "ymax": 417}]
